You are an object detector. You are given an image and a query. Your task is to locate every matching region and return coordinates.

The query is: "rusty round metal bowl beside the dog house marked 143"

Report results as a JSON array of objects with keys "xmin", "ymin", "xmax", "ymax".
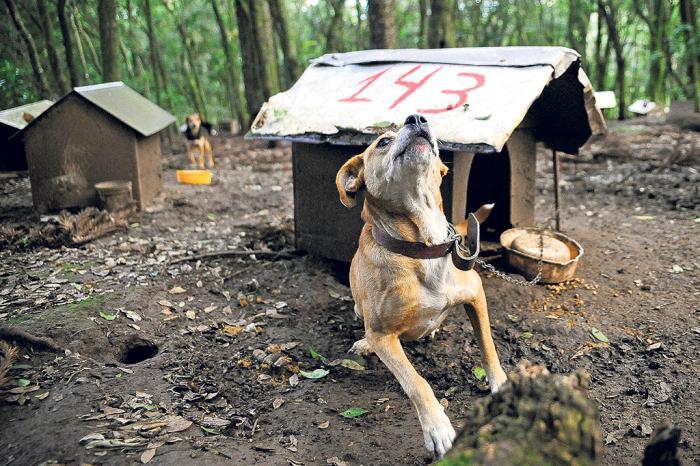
[{"xmin": 501, "ymin": 228, "xmax": 583, "ymax": 283}]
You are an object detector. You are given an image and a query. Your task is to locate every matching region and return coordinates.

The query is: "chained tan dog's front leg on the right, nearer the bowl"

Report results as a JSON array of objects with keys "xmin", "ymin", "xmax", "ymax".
[{"xmin": 464, "ymin": 284, "xmax": 508, "ymax": 393}]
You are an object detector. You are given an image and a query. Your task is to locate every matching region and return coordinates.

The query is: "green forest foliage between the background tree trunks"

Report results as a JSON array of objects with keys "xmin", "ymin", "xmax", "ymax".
[{"xmin": 0, "ymin": 0, "xmax": 699, "ymax": 121}]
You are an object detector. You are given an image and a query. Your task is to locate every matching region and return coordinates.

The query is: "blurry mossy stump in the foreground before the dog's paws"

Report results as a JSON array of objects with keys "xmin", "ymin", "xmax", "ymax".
[{"xmin": 437, "ymin": 363, "xmax": 602, "ymax": 466}]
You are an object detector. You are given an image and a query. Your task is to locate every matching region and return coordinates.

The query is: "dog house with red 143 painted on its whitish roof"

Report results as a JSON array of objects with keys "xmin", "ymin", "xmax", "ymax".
[{"xmin": 247, "ymin": 47, "xmax": 605, "ymax": 261}]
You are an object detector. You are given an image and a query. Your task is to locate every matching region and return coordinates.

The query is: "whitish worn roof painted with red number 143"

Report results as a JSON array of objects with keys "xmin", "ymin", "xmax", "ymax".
[{"xmin": 249, "ymin": 47, "xmax": 605, "ymax": 153}]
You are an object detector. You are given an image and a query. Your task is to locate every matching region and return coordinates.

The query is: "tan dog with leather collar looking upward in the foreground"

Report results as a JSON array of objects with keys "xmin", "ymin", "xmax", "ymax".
[{"xmin": 336, "ymin": 115, "xmax": 506, "ymax": 456}]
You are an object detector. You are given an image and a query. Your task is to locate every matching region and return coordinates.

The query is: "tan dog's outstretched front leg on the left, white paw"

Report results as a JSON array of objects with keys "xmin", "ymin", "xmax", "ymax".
[{"xmin": 360, "ymin": 332, "xmax": 456, "ymax": 457}]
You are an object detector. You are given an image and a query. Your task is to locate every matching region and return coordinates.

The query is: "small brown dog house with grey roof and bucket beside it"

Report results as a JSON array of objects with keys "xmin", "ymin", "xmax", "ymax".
[{"xmin": 13, "ymin": 82, "xmax": 175, "ymax": 212}]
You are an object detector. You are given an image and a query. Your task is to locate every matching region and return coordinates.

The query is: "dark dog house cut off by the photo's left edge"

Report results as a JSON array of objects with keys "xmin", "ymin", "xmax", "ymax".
[{"xmin": 0, "ymin": 100, "xmax": 53, "ymax": 172}]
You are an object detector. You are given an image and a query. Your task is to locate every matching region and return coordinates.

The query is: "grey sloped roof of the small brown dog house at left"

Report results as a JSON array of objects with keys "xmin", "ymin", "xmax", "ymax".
[{"xmin": 73, "ymin": 81, "xmax": 175, "ymax": 136}]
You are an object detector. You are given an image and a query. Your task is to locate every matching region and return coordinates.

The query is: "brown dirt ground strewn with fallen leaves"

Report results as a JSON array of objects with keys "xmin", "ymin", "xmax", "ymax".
[{"xmin": 0, "ymin": 120, "xmax": 700, "ymax": 465}]
